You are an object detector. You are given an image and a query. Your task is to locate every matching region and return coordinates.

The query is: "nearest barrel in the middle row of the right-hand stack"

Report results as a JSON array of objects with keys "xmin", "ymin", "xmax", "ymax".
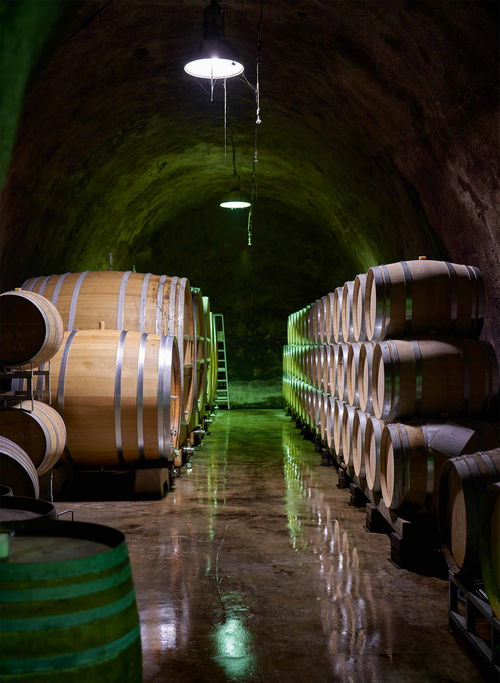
[{"xmin": 372, "ymin": 339, "xmax": 498, "ymax": 420}]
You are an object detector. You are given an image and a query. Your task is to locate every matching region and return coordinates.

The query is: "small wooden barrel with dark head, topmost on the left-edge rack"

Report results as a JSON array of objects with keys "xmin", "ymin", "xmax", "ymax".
[{"xmin": 0, "ymin": 290, "xmax": 63, "ymax": 367}]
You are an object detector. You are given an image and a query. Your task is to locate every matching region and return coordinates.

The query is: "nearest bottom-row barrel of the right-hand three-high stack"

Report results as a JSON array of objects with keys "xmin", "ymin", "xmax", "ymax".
[{"xmin": 380, "ymin": 422, "xmax": 498, "ymax": 515}]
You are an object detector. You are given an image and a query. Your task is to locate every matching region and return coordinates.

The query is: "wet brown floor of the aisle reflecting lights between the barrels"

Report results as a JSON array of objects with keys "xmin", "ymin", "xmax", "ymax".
[{"xmin": 58, "ymin": 410, "xmax": 483, "ymax": 683}]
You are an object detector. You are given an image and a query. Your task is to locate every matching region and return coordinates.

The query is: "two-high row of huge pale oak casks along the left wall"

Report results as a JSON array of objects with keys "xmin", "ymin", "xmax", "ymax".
[{"xmin": 0, "ymin": 271, "xmax": 217, "ymax": 492}]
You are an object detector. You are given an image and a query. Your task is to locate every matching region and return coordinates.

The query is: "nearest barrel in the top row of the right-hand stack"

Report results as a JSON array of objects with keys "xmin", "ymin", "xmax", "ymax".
[{"xmin": 365, "ymin": 259, "xmax": 484, "ymax": 340}]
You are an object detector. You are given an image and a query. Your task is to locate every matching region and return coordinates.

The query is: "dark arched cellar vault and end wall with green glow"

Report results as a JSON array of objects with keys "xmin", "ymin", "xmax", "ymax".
[{"xmin": 0, "ymin": 0, "xmax": 500, "ymax": 406}]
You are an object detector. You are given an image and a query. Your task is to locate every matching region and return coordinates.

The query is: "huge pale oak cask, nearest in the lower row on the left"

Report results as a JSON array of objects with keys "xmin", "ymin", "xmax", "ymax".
[{"xmin": 46, "ymin": 330, "xmax": 181, "ymax": 466}]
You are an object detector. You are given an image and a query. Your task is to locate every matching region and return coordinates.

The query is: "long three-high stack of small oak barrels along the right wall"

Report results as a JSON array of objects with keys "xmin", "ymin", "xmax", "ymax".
[{"xmin": 283, "ymin": 258, "xmax": 500, "ymax": 560}]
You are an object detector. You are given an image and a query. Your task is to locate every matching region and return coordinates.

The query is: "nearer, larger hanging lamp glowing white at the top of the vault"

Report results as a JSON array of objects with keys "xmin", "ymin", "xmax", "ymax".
[{"xmin": 184, "ymin": 0, "xmax": 244, "ymax": 81}]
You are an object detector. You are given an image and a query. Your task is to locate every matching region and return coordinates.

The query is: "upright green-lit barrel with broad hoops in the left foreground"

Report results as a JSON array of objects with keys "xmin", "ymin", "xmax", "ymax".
[{"xmin": 0, "ymin": 522, "xmax": 142, "ymax": 683}]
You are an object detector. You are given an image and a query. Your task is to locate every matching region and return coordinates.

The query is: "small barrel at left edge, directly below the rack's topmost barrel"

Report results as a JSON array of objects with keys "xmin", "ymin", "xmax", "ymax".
[{"xmin": 0, "ymin": 401, "xmax": 66, "ymax": 476}]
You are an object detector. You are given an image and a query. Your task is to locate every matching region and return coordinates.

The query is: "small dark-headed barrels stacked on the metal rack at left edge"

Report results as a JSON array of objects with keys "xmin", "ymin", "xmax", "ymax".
[{"xmin": 0, "ymin": 291, "xmax": 66, "ymax": 498}]
